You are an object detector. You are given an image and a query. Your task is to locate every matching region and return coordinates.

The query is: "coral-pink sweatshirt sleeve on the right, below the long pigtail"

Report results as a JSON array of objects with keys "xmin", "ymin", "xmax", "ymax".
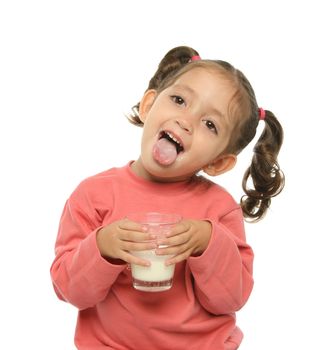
[{"xmin": 188, "ymin": 207, "xmax": 253, "ymax": 315}]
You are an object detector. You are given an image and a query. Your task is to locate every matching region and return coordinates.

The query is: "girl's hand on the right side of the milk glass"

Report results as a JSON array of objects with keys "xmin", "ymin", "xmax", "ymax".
[{"xmin": 156, "ymin": 220, "xmax": 212, "ymax": 265}]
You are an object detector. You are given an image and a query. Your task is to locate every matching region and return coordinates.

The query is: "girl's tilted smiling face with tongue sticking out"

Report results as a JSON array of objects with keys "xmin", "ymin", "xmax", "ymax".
[{"xmin": 134, "ymin": 68, "xmax": 234, "ymax": 181}]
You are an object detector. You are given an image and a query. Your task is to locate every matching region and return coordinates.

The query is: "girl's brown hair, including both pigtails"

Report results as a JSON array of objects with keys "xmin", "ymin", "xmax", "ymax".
[{"xmin": 128, "ymin": 46, "xmax": 284, "ymax": 221}]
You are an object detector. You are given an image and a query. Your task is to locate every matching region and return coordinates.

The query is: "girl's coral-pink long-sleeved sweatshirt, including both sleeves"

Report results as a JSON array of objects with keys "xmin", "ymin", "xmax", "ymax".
[{"xmin": 51, "ymin": 165, "xmax": 253, "ymax": 350}]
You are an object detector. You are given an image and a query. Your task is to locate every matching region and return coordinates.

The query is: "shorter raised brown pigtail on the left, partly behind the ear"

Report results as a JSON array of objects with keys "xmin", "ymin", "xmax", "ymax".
[{"xmin": 127, "ymin": 46, "xmax": 199, "ymax": 126}]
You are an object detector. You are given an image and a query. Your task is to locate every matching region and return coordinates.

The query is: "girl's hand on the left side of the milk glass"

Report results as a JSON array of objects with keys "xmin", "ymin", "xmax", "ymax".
[{"xmin": 97, "ymin": 219, "xmax": 157, "ymax": 266}]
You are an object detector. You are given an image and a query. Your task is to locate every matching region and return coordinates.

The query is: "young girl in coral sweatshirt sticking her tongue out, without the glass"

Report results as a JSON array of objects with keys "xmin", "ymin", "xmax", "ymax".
[{"xmin": 51, "ymin": 47, "xmax": 283, "ymax": 350}]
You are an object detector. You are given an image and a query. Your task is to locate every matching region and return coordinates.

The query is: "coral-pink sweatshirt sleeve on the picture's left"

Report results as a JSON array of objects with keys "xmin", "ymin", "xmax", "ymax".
[{"xmin": 50, "ymin": 182, "xmax": 126, "ymax": 309}]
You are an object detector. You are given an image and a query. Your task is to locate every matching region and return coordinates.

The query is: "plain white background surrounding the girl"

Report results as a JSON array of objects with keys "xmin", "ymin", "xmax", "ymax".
[{"xmin": 0, "ymin": 0, "xmax": 313, "ymax": 350}]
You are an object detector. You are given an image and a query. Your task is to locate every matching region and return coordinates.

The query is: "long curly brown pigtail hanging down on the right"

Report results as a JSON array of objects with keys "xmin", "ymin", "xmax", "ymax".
[{"xmin": 241, "ymin": 111, "xmax": 284, "ymax": 221}]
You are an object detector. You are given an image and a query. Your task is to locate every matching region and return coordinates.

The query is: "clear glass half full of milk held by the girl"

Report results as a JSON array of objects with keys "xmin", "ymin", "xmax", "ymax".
[{"xmin": 127, "ymin": 212, "xmax": 182, "ymax": 292}]
